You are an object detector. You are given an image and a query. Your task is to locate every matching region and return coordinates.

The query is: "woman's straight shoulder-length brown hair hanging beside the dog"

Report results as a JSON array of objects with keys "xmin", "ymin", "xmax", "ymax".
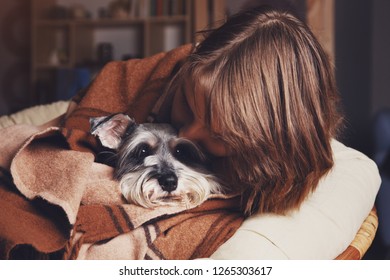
[{"xmin": 168, "ymin": 7, "xmax": 341, "ymax": 215}]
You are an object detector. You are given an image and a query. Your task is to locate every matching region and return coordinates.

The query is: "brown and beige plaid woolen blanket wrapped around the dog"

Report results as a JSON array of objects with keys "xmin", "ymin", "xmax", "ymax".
[{"xmin": 0, "ymin": 46, "xmax": 242, "ymax": 259}]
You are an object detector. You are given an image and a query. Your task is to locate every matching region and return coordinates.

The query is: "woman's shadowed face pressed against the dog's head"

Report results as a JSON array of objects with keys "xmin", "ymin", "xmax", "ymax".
[{"xmin": 171, "ymin": 80, "xmax": 229, "ymax": 157}]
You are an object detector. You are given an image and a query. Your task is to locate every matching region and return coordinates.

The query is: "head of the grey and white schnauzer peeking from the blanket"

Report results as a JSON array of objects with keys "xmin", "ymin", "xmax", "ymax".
[{"xmin": 90, "ymin": 114, "xmax": 222, "ymax": 208}]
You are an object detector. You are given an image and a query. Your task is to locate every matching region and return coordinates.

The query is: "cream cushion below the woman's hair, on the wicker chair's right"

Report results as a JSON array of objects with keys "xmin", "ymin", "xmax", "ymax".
[{"xmin": 212, "ymin": 140, "xmax": 381, "ymax": 259}]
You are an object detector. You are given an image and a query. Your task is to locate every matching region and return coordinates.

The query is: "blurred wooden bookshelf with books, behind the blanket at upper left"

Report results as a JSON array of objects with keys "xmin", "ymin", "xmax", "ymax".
[{"xmin": 30, "ymin": 0, "xmax": 196, "ymax": 105}]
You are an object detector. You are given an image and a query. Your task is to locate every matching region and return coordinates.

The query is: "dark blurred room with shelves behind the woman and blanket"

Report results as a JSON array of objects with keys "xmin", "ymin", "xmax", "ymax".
[{"xmin": 0, "ymin": 0, "xmax": 390, "ymax": 259}]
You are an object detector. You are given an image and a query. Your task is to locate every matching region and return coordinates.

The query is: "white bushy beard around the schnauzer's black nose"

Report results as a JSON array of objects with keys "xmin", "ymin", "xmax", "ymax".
[{"xmin": 120, "ymin": 163, "xmax": 221, "ymax": 208}]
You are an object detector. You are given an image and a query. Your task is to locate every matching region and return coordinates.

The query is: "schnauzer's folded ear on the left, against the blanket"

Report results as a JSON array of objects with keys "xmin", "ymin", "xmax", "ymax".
[{"xmin": 89, "ymin": 114, "xmax": 137, "ymax": 149}]
